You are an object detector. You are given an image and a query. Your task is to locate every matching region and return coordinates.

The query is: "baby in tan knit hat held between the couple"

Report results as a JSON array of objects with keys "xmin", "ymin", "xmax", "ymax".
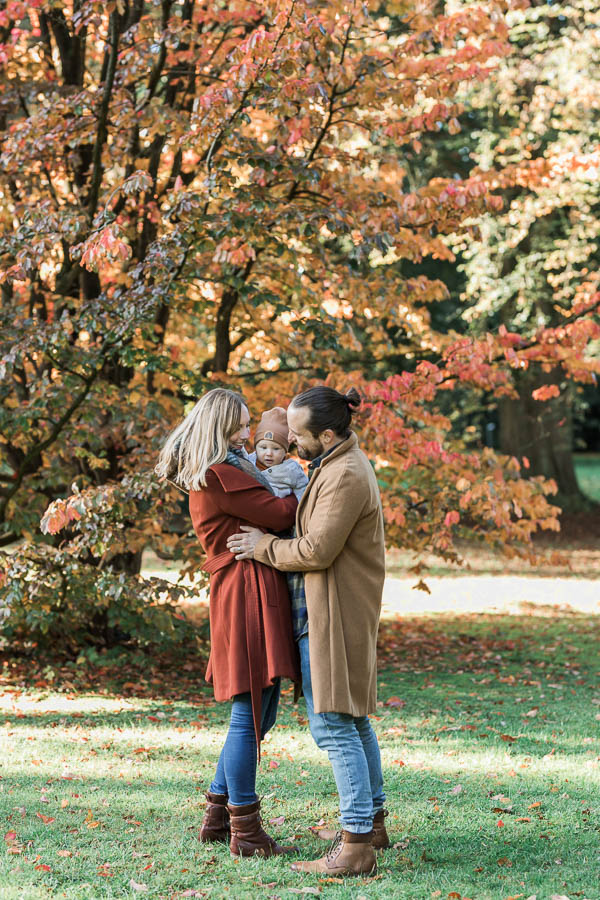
[{"xmin": 250, "ymin": 406, "xmax": 308, "ymax": 502}]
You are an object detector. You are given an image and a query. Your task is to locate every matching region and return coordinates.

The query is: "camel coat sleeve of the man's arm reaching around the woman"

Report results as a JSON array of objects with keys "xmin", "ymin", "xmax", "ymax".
[{"xmin": 254, "ymin": 467, "xmax": 366, "ymax": 572}]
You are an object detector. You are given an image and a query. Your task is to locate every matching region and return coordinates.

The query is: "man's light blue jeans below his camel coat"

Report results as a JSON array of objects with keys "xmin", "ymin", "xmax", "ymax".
[{"xmin": 298, "ymin": 634, "xmax": 385, "ymax": 834}]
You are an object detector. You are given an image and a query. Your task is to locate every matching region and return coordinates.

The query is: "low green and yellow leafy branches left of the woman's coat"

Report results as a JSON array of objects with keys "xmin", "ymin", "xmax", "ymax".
[{"xmin": 0, "ymin": 473, "xmax": 202, "ymax": 652}]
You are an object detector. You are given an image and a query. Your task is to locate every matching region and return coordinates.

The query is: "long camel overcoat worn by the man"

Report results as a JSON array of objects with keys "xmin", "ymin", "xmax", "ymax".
[{"xmin": 254, "ymin": 433, "xmax": 385, "ymax": 716}]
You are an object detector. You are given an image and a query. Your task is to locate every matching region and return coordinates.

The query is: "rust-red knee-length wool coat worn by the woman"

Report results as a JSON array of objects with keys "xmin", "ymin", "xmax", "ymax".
[{"xmin": 190, "ymin": 463, "xmax": 299, "ymax": 741}]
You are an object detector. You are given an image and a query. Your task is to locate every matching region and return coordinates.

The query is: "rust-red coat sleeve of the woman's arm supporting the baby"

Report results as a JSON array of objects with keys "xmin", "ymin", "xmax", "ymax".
[{"xmin": 206, "ymin": 471, "xmax": 298, "ymax": 531}]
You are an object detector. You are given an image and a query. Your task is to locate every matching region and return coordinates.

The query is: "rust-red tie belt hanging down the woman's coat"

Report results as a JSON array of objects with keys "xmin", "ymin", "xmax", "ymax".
[{"xmin": 202, "ymin": 550, "xmax": 266, "ymax": 761}]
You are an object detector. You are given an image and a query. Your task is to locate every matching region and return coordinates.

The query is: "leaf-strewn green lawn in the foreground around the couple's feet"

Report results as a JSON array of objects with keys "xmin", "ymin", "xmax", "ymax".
[{"xmin": 0, "ymin": 610, "xmax": 600, "ymax": 900}]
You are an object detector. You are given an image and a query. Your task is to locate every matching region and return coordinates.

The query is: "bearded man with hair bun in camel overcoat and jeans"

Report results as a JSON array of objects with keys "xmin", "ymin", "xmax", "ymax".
[{"xmin": 228, "ymin": 385, "xmax": 389, "ymax": 875}]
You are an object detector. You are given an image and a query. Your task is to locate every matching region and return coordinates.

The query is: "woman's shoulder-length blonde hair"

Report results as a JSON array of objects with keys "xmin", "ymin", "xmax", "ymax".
[{"xmin": 154, "ymin": 388, "xmax": 246, "ymax": 491}]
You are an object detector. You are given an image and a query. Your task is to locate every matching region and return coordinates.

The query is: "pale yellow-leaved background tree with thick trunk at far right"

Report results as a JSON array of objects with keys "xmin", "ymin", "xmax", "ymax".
[{"xmin": 450, "ymin": 2, "xmax": 600, "ymax": 507}]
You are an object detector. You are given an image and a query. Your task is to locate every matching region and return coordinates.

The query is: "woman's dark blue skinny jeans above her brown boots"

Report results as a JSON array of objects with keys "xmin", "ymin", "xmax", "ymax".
[{"xmin": 209, "ymin": 678, "xmax": 280, "ymax": 806}]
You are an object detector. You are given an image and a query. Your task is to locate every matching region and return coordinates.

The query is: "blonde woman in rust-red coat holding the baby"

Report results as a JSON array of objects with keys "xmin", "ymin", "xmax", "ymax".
[{"xmin": 156, "ymin": 388, "xmax": 299, "ymax": 856}]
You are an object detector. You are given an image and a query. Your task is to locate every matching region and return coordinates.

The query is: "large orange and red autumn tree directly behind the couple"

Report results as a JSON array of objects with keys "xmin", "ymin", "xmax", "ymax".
[{"xmin": 0, "ymin": 0, "xmax": 597, "ymax": 648}]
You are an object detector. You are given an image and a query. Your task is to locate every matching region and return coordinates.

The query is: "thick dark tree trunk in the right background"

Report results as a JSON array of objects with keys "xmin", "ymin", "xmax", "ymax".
[{"xmin": 499, "ymin": 367, "xmax": 584, "ymax": 509}]
